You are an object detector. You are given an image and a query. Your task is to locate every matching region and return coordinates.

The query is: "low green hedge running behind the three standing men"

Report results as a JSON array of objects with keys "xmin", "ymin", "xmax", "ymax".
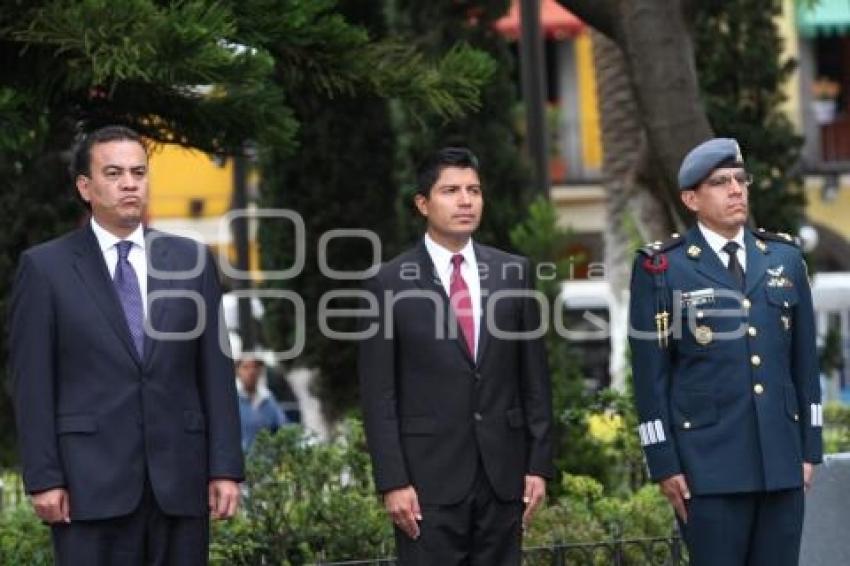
[{"xmin": 0, "ymin": 419, "xmax": 673, "ymax": 566}]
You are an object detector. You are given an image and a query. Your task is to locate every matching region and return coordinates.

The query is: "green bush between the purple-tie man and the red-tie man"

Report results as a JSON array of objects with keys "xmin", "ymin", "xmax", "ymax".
[{"xmin": 211, "ymin": 420, "xmax": 392, "ymax": 566}]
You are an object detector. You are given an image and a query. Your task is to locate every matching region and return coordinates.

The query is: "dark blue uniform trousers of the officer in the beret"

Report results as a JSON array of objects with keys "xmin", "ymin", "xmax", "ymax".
[{"xmin": 679, "ymin": 488, "xmax": 805, "ymax": 566}]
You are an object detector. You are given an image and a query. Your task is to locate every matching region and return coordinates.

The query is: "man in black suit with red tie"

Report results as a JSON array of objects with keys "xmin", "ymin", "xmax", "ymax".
[{"xmin": 359, "ymin": 148, "xmax": 553, "ymax": 566}]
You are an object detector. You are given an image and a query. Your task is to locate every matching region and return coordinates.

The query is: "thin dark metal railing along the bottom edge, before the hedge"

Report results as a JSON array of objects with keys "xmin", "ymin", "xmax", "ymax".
[{"xmin": 316, "ymin": 531, "xmax": 688, "ymax": 566}]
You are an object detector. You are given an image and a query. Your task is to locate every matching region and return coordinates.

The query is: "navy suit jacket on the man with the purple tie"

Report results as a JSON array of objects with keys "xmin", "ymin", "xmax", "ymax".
[{"xmin": 10, "ymin": 225, "xmax": 243, "ymax": 519}]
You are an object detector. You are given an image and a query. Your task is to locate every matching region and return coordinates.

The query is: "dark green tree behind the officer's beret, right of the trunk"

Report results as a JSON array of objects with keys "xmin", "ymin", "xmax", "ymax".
[{"xmin": 693, "ymin": 0, "xmax": 805, "ymax": 232}]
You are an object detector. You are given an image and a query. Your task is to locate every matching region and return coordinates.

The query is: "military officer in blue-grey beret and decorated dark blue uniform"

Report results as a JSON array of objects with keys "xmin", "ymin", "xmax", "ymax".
[{"xmin": 629, "ymin": 138, "xmax": 823, "ymax": 566}]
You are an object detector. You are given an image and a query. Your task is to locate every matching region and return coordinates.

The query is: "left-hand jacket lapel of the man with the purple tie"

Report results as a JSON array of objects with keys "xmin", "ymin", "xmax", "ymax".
[{"xmin": 74, "ymin": 225, "xmax": 140, "ymax": 363}]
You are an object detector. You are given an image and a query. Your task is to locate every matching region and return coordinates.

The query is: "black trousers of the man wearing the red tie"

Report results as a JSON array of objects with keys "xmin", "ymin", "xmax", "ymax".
[{"xmin": 395, "ymin": 464, "xmax": 524, "ymax": 566}]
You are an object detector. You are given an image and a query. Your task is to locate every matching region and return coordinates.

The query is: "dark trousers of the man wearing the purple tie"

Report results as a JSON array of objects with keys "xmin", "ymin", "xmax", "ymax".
[{"xmin": 51, "ymin": 481, "xmax": 209, "ymax": 566}]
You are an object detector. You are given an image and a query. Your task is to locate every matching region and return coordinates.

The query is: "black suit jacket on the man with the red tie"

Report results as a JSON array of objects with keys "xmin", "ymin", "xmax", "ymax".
[{"xmin": 359, "ymin": 242, "xmax": 553, "ymax": 504}]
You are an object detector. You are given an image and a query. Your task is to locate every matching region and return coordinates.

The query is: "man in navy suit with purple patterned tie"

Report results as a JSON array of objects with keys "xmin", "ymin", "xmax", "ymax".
[{"xmin": 10, "ymin": 126, "xmax": 243, "ymax": 566}]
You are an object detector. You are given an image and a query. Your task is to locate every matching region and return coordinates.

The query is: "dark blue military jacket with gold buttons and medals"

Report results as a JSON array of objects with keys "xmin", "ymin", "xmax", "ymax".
[{"xmin": 629, "ymin": 226, "xmax": 822, "ymax": 495}]
